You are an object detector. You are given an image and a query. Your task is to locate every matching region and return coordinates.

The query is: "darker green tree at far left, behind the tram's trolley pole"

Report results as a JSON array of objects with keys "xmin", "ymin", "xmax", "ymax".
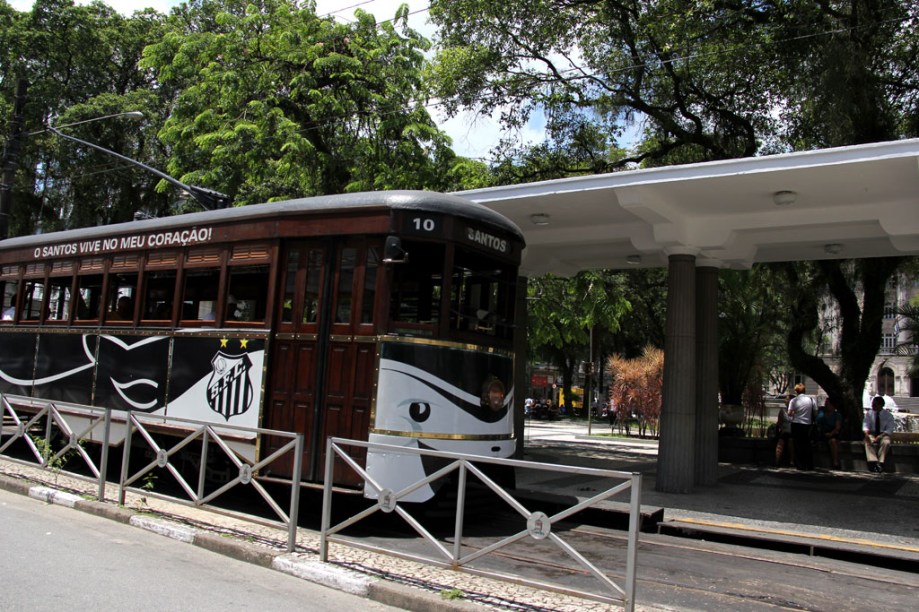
[{"xmin": 0, "ymin": 0, "xmax": 171, "ymax": 235}]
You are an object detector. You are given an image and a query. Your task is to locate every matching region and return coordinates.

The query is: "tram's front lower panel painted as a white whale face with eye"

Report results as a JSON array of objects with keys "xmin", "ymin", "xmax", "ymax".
[{"xmin": 364, "ymin": 342, "xmax": 515, "ymax": 502}]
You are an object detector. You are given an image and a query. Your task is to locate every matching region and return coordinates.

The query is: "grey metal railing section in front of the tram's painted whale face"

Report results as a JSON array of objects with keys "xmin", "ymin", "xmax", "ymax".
[{"xmin": 319, "ymin": 438, "xmax": 641, "ymax": 610}]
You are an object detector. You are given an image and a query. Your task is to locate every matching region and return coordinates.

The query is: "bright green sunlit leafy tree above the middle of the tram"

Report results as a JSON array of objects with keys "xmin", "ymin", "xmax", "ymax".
[{"xmin": 142, "ymin": 0, "xmax": 457, "ymax": 204}]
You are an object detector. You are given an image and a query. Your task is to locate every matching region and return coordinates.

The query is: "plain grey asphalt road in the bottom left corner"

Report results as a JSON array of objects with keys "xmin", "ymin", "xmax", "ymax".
[{"xmin": 0, "ymin": 490, "xmax": 397, "ymax": 612}]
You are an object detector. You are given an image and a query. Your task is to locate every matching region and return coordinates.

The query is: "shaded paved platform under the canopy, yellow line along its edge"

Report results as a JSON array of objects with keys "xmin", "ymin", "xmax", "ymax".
[{"xmin": 518, "ymin": 420, "xmax": 919, "ymax": 571}]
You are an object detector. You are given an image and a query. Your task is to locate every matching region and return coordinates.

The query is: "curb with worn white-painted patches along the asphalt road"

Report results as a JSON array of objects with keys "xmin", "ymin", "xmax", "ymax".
[{"xmin": 0, "ymin": 474, "xmax": 482, "ymax": 612}]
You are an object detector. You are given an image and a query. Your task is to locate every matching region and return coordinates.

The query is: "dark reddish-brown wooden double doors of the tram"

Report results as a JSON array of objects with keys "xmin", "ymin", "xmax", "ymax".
[{"xmin": 262, "ymin": 240, "xmax": 379, "ymax": 485}]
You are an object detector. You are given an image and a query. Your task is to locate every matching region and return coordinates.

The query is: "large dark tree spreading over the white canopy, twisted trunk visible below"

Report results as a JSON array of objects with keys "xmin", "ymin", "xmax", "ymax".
[{"xmin": 431, "ymin": 0, "xmax": 919, "ymax": 442}]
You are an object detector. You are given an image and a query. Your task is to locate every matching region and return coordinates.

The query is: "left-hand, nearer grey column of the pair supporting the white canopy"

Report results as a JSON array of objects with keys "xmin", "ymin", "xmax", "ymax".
[{"xmin": 655, "ymin": 252, "xmax": 696, "ymax": 493}]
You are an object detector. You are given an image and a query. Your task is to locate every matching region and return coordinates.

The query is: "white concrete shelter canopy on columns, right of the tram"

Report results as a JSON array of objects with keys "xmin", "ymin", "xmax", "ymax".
[{"xmin": 456, "ymin": 139, "xmax": 919, "ymax": 275}]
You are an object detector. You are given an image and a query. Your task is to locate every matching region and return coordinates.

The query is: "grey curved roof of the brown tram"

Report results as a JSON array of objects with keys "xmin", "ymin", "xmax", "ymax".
[{"xmin": 0, "ymin": 190, "xmax": 523, "ymax": 249}]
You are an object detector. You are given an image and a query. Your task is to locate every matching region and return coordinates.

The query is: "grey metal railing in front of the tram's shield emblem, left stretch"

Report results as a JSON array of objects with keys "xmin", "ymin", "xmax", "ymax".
[{"xmin": 0, "ymin": 394, "xmax": 303, "ymax": 552}]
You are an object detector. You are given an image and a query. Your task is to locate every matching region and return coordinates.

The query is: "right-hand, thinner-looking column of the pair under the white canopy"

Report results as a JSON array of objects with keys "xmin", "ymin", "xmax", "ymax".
[{"xmin": 695, "ymin": 264, "xmax": 718, "ymax": 486}]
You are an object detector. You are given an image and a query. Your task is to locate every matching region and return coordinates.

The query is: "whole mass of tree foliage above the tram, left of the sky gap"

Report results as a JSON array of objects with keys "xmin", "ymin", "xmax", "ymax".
[{"xmin": 0, "ymin": 0, "xmax": 468, "ymax": 235}]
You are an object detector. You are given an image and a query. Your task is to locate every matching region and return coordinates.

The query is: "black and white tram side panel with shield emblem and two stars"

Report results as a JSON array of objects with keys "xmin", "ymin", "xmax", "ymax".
[{"xmin": 0, "ymin": 332, "xmax": 266, "ymax": 460}]
